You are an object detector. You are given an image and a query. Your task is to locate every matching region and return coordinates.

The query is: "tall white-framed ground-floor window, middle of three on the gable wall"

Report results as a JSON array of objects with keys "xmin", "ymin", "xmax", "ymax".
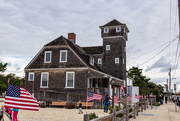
[{"xmin": 40, "ymin": 72, "xmax": 49, "ymax": 88}]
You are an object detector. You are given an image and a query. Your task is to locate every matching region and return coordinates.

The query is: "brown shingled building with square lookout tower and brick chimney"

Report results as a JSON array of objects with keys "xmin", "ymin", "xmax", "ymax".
[{"xmin": 25, "ymin": 19, "xmax": 129, "ymax": 105}]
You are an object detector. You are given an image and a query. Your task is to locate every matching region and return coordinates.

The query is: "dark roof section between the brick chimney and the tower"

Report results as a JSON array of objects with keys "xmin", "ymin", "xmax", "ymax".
[{"xmin": 82, "ymin": 46, "xmax": 103, "ymax": 54}]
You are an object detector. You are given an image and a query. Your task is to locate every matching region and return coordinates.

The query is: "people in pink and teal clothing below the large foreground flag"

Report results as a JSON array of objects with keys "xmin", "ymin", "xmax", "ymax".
[{"xmin": 0, "ymin": 106, "xmax": 19, "ymax": 121}]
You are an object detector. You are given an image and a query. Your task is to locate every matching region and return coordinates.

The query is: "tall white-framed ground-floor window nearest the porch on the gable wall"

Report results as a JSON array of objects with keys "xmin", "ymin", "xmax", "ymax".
[{"xmin": 66, "ymin": 72, "xmax": 75, "ymax": 88}]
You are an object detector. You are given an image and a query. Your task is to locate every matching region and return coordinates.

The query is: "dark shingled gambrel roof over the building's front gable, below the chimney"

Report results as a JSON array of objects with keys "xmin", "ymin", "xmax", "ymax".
[{"xmin": 45, "ymin": 36, "xmax": 102, "ymax": 71}]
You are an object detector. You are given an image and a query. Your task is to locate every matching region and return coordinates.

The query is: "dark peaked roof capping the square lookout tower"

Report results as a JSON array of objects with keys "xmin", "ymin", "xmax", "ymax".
[{"xmin": 99, "ymin": 19, "xmax": 129, "ymax": 32}]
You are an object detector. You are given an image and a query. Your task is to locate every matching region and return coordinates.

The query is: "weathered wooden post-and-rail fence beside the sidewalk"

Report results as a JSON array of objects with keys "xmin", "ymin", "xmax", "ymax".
[{"xmin": 84, "ymin": 99, "xmax": 148, "ymax": 121}]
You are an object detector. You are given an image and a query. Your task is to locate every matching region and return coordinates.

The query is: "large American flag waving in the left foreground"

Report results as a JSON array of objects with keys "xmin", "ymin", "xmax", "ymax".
[{"xmin": 4, "ymin": 84, "xmax": 39, "ymax": 111}]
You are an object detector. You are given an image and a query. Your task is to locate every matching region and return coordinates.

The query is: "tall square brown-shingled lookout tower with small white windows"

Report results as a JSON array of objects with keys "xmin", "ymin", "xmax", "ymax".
[{"xmin": 100, "ymin": 19, "xmax": 129, "ymax": 80}]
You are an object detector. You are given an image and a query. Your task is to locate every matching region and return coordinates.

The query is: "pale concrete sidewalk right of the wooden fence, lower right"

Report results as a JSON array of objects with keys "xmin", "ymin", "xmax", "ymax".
[{"xmin": 130, "ymin": 103, "xmax": 180, "ymax": 121}]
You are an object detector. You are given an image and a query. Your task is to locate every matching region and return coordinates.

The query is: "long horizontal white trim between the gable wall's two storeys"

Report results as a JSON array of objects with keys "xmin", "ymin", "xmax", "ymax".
[{"xmin": 24, "ymin": 67, "xmax": 88, "ymax": 71}]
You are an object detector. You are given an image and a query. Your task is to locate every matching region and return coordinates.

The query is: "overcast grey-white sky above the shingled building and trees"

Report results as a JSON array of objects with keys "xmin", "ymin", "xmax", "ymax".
[{"xmin": 0, "ymin": 0, "xmax": 180, "ymax": 90}]
